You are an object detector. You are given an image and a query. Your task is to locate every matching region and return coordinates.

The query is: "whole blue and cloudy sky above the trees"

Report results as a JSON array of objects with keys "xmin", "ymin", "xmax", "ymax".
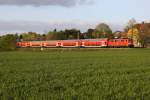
[{"xmin": 0, "ymin": 0, "xmax": 150, "ymax": 34}]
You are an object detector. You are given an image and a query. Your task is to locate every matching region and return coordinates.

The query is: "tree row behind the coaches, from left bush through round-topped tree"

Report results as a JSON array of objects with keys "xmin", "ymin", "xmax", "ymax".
[{"xmin": 19, "ymin": 23, "xmax": 113, "ymax": 41}]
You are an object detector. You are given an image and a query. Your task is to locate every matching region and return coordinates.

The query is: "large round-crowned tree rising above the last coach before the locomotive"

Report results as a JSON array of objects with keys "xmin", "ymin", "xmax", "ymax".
[{"xmin": 94, "ymin": 23, "xmax": 112, "ymax": 38}]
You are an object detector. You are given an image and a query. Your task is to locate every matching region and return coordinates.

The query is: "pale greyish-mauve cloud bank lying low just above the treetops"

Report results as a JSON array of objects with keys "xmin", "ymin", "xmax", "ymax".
[{"xmin": 0, "ymin": 21, "xmax": 124, "ymax": 35}]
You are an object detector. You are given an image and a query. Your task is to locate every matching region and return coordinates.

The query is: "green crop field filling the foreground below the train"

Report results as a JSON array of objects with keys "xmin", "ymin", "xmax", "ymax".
[{"xmin": 0, "ymin": 49, "xmax": 150, "ymax": 100}]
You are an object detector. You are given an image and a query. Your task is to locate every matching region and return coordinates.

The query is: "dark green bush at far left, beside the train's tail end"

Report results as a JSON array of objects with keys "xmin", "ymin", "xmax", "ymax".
[{"xmin": 0, "ymin": 34, "xmax": 17, "ymax": 50}]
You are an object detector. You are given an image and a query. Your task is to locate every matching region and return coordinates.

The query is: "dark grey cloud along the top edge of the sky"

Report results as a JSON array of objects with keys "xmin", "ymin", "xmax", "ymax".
[{"xmin": 0, "ymin": 0, "xmax": 94, "ymax": 7}]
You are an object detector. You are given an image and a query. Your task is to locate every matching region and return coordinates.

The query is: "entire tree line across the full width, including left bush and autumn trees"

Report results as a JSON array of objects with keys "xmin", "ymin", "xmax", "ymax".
[{"xmin": 0, "ymin": 19, "xmax": 150, "ymax": 50}]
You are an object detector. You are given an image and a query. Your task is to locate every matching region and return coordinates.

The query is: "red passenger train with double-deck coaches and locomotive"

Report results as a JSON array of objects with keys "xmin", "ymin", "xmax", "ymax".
[{"xmin": 17, "ymin": 38, "xmax": 134, "ymax": 48}]
